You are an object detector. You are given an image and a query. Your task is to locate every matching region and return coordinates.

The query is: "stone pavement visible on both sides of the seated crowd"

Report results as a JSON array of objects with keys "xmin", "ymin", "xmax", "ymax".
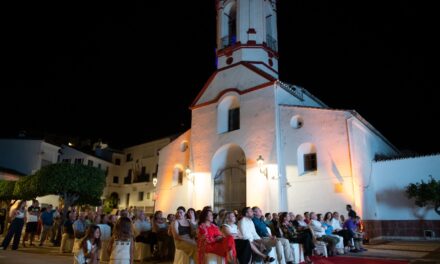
[{"xmin": 0, "ymin": 238, "xmax": 440, "ymax": 264}]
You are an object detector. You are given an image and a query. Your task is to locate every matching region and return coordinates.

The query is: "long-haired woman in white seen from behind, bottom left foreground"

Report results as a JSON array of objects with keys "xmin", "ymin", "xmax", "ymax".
[{"xmin": 107, "ymin": 216, "xmax": 134, "ymax": 264}]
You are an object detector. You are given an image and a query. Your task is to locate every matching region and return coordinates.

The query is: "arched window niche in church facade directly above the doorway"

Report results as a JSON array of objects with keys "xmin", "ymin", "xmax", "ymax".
[{"xmin": 217, "ymin": 96, "xmax": 240, "ymax": 134}]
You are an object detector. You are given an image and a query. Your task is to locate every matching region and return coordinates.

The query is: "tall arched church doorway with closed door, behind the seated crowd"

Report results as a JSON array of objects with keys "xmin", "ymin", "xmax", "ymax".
[{"xmin": 212, "ymin": 144, "xmax": 246, "ymax": 212}]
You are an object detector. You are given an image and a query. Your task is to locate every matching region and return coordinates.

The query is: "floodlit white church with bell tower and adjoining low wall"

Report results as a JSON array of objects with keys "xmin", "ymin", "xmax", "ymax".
[{"xmin": 155, "ymin": 0, "xmax": 440, "ymax": 237}]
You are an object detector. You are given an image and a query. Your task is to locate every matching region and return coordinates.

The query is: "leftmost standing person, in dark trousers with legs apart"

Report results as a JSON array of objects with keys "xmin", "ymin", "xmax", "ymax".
[{"xmin": 0, "ymin": 200, "xmax": 26, "ymax": 250}]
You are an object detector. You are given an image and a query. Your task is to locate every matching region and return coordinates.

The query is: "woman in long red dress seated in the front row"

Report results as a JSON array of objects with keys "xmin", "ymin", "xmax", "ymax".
[{"xmin": 197, "ymin": 210, "xmax": 237, "ymax": 264}]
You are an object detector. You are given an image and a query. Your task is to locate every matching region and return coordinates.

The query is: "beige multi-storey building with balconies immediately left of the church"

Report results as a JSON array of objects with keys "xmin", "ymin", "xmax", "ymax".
[{"xmin": 103, "ymin": 138, "xmax": 171, "ymax": 213}]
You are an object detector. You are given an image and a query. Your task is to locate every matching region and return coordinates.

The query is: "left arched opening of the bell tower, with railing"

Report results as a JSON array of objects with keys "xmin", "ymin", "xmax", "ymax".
[{"xmin": 222, "ymin": 1, "xmax": 237, "ymax": 48}]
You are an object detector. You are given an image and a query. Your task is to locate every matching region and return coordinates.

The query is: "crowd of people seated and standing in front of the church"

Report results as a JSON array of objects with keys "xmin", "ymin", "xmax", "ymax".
[{"xmin": 0, "ymin": 200, "xmax": 365, "ymax": 264}]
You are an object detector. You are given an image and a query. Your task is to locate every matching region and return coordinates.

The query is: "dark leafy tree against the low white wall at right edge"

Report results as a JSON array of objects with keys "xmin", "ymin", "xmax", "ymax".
[{"xmin": 405, "ymin": 175, "xmax": 440, "ymax": 215}]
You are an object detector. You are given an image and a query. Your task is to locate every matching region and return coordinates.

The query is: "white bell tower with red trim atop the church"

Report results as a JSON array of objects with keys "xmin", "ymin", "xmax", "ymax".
[{"xmin": 216, "ymin": 0, "xmax": 278, "ymax": 79}]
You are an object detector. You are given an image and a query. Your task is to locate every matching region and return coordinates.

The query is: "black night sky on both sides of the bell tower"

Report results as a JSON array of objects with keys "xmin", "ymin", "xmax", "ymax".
[{"xmin": 0, "ymin": 0, "xmax": 440, "ymax": 153}]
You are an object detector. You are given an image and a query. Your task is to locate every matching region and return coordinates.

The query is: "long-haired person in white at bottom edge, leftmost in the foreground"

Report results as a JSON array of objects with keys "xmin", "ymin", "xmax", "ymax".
[{"xmin": 73, "ymin": 225, "xmax": 101, "ymax": 264}]
